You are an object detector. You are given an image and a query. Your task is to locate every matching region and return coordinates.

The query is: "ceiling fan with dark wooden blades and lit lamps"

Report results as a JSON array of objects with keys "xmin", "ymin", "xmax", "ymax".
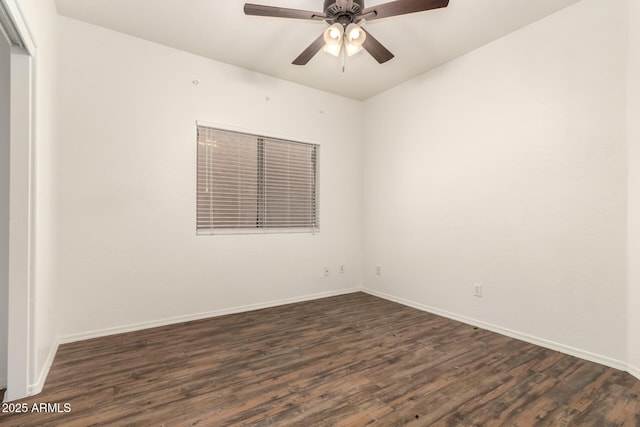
[{"xmin": 244, "ymin": 0, "xmax": 449, "ymax": 65}]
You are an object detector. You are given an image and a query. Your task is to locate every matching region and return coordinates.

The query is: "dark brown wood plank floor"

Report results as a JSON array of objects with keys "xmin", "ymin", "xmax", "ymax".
[{"xmin": 0, "ymin": 293, "xmax": 640, "ymax": 427}]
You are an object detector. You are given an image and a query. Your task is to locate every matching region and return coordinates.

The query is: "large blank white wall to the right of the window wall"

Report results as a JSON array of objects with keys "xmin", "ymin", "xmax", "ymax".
[{"xmin": 363, "ymin": 0, "xmax": 627, "ymax": 367}]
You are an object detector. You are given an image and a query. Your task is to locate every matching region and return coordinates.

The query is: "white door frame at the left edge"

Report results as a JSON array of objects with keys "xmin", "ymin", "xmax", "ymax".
[{"xmin": 0, "ymin": 0, "xmax": 36, "ymax": 401}]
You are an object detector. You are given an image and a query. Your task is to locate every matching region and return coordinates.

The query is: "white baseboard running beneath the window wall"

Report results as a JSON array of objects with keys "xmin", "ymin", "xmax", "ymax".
[{"xmin": 59, "ymin": 288, "xmax": 363, "ymax": 344}]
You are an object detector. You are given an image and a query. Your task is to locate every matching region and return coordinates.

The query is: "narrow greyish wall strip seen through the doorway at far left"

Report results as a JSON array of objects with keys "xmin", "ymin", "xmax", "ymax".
[{"xmin": 0, "ymin": 25, "xmax": 11, "ymax": 389}]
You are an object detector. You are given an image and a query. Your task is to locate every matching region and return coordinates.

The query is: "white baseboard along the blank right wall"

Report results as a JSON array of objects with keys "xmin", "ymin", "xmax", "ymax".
[{"xmin": 362, "ymin": 288, "xmax": 628, "ymax": 372}]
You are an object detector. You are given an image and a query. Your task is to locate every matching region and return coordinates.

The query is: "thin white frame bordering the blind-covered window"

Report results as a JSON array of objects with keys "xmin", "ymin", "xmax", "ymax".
[{"xmin": 194, "ymin": 120, "xmax": 321, "ymax": 236}]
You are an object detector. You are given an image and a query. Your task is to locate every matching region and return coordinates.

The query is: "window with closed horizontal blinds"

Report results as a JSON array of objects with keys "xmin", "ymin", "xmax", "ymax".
[{"xmin": 196, "ymin": 125, "xmax": 320, "ymax": 234}]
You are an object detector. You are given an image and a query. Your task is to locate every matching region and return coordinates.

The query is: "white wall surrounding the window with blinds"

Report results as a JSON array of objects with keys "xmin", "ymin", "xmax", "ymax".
[{"xmin": 56, "ymin": 18, "xmax": 362, "ymax": 340}]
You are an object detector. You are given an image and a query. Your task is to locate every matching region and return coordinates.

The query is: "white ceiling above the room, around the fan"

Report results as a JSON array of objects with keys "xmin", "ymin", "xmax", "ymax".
[{"xmin": 57, "ymin": 0, "xmax": 579, "ymax": 100}]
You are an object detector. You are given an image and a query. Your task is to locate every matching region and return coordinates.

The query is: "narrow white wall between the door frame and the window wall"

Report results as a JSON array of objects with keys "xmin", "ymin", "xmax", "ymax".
[{"xmin": 17, "ymin": 0, "xmax": 58, "ymax": 393}]
